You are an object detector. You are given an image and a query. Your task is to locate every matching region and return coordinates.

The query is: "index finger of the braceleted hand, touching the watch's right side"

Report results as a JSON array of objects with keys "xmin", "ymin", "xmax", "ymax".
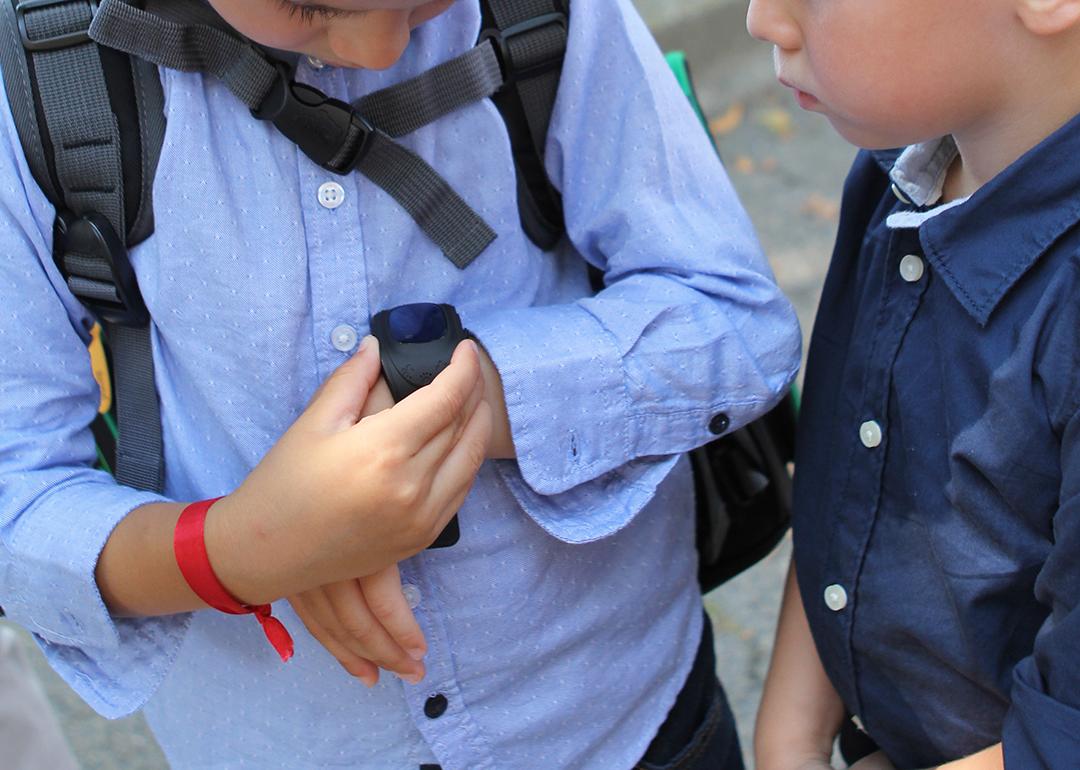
[{"xmin": 365, "ymin": 340, "xmax": 482, "ymax": 456}]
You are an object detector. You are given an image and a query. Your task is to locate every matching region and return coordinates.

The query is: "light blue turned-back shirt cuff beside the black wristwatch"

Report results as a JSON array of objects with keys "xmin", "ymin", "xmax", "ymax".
[{"xmin": 464, "ymin": 303, "xmax": 630, "ymax": 495}]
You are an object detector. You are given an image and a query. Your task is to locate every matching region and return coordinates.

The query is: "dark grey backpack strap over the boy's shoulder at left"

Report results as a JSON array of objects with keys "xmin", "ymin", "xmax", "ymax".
[{"xmin": 0, "ymin": 0, "xmax": 164, "ymax": 491}]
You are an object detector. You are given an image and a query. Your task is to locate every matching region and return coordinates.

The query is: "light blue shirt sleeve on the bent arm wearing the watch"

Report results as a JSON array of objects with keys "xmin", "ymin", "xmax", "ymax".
[{"xmin": 467, "ymin": 0, "xmax": 800, "ymax": 541}]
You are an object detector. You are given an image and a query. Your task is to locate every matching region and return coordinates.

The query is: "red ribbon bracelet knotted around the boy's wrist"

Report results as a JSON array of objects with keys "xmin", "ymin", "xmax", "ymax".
[{"xmin": 173, "ymin": 498, "xmax": 293, "ymax": 661}]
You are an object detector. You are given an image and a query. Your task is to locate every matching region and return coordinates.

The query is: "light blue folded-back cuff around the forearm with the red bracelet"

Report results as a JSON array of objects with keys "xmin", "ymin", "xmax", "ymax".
[{"xmin": 0, "ymin": 471, "xmax": 189, "ymax": 718}]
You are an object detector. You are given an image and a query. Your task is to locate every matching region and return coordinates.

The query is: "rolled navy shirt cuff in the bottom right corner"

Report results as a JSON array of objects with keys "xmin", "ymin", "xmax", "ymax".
[{"xmin": 1002, "ymin": 658, "xmax": 1080, "ymax": 770}]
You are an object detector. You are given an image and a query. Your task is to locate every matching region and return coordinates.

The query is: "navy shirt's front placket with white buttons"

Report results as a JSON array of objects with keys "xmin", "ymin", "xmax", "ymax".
[{"xmin": 816, "ymin": 225, "xmax": 928, "ymax": 724}]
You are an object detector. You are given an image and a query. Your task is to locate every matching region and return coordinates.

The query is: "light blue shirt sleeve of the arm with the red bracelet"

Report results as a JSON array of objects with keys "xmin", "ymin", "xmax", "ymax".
[{"xmin": 0, "ymin": 89, "xmax": 187, "ymax": 717}]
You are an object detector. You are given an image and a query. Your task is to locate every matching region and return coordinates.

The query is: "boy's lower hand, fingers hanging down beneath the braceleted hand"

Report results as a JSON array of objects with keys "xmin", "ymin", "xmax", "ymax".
[{"xmin": 288, "ymin": 565, "xmax": 428, "ymax": 687}]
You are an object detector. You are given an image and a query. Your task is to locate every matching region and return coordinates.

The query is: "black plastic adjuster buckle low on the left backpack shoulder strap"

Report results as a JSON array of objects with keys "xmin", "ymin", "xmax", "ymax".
[{"xmin": 53, "ymin": 212, "xmax": 150, "ymax": 326}]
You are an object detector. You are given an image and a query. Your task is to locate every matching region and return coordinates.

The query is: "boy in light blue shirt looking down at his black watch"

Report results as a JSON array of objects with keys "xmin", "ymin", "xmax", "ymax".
[{"xmin": 0, "ymin": 0, "xmax": 799, "ymax": 770}]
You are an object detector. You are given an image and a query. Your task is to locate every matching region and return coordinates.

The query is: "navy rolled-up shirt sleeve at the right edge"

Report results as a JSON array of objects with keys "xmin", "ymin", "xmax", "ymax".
[{"xmin": 1003, "ymin": 401, "xmax": 1080, "ymax": 770}]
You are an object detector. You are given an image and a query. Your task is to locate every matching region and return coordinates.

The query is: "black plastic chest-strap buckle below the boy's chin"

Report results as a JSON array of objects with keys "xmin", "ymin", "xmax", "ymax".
[{"xmin": 252, "ymin": 63, "xmax": 375, "ymax": 175}]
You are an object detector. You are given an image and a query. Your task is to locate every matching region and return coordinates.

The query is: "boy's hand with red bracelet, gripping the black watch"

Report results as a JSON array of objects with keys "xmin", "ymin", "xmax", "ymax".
[{"xmin": 206, "ymin": 338, "xmax": 491, "ymax": 604}]
